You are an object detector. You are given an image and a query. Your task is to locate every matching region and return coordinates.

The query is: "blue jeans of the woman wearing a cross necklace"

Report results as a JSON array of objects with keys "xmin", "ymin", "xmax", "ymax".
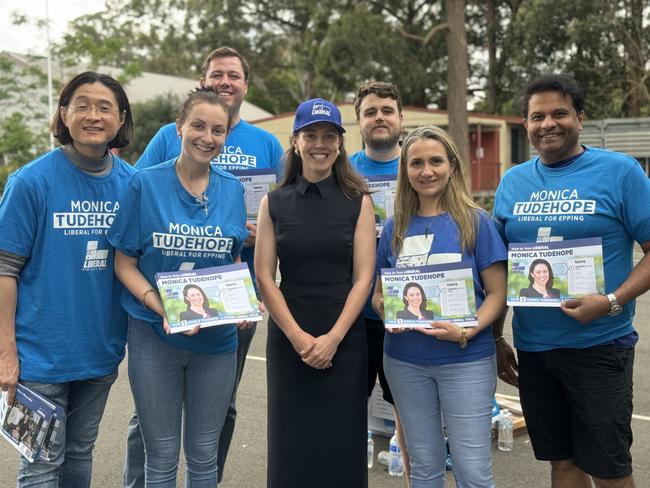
[{"xmin": 128, "ymin": 318, "xmax": 236, "ymax": 488}]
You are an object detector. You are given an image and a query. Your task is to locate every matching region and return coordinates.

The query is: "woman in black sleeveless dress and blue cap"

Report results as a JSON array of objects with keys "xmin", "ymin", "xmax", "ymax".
[{"xmin": 255, "ymin": 99, "xmax": 375, "ymax": 488}]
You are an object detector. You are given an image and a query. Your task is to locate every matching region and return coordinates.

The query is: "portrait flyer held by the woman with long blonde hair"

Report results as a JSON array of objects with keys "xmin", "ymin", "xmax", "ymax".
[{"xmin": 381, "ymin": 262, "xmax": 478, "ymax": 329}]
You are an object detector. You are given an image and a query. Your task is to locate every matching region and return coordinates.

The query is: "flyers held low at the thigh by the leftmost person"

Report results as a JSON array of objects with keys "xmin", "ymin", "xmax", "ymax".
[{"xmin": 0, "ymin": 383, "xmax": 57, "ymax": 463}]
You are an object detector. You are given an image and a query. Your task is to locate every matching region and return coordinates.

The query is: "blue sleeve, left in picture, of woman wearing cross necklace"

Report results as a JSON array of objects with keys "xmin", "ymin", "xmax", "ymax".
[{"xmin": 107, "ymin": 174, "xmax": 142, "ymax": 257}]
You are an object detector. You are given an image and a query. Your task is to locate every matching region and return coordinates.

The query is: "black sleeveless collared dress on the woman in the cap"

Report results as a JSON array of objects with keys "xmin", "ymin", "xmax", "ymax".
[{"xmin": 266, "ymin": 175, "xmax": 368, "ymax": 488}]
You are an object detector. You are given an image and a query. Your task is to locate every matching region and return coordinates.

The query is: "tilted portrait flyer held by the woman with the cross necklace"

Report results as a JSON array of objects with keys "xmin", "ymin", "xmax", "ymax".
[{"xmin": 156, "ymin": 263, "xmax": 262, "ymax": 334}]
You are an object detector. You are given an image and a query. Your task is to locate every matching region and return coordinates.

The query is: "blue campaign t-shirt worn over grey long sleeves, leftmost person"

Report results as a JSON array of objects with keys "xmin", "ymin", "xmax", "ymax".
[{"xmin": 0, "ymin": 148, "xmax": 134, "ymax": 383}]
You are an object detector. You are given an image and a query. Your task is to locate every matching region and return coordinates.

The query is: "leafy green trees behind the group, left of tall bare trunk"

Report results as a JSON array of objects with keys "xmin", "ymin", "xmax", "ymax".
[{"xmin": 54, "ymin": 0, "xmax": 446, "ymax": 113}]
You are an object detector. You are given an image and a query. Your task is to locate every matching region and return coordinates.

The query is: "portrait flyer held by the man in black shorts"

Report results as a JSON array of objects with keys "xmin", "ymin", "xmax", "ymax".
[{"xmin": 508, "ymin": 237, "xmax": 605, "ymax": 307}]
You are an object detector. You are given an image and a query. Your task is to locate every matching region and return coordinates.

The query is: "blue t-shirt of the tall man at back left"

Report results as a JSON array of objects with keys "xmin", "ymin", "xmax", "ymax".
[{"xmin": 135, "ymin": 120, "xmax": 283, "ymax": 288}]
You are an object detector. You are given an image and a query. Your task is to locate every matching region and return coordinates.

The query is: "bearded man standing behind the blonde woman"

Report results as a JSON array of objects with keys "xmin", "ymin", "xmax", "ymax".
[{"xmin": 350, "ymin": 81, "xmax": 409, "ymax": 479}]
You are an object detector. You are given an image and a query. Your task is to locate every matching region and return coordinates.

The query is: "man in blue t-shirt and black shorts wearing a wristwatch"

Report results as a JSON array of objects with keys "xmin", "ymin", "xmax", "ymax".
[{"xmin": 494, "ymin": 75, "xmax": 650, "ymax": 487}]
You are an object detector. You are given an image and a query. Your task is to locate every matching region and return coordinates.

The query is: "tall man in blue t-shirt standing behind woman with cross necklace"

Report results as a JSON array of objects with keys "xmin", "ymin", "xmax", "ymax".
[{"xmin": 124, "ymin": 47, "xmax": 283, "ymax": 487}]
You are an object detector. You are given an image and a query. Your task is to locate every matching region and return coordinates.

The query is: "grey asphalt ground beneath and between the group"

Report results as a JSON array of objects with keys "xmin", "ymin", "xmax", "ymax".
[{"xmin": 0, "ymin": 294, "xmax": 650, "ymax": 488}]
